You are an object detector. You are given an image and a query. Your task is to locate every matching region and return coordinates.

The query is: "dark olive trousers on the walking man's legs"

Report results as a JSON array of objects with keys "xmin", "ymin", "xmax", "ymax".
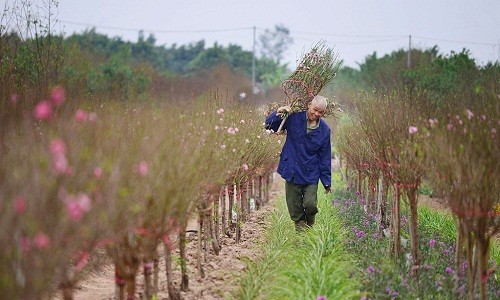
[{"xmin": 285, "ymin": 181, "xmax": 318, "ymax": 226}]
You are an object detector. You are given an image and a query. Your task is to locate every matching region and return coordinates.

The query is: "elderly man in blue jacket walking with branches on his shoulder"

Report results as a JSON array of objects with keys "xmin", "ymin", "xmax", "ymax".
[{"xmin": 266, "ymin": 95, "xmax": 332, "ymax": 230}]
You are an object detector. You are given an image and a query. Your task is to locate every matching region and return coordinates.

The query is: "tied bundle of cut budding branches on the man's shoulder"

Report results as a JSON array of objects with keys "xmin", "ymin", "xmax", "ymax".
[{"xmin": 268, "ymin": 41, "xmax": 342, "ymax": 133}]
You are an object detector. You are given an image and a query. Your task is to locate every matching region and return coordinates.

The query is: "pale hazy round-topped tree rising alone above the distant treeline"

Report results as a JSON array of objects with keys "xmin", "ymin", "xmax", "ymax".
[{"xmin": 259, "ymin": 24, "xmax": 293, "ymax": 64}]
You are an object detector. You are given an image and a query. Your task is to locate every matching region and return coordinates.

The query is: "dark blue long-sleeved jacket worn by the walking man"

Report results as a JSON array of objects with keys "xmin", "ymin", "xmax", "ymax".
[{"xmin": 265, "ymin": 111, "xmax": 332, "ymax": 187}]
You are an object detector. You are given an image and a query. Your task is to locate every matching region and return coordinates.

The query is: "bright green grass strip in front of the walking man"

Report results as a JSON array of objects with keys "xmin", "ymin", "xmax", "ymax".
[{"xmin": 236, "ymin": 191, "xmax": 361, "ymax": 299}]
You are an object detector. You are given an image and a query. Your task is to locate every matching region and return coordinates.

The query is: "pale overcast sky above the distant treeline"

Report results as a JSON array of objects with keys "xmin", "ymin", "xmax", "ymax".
[{"xmin": 31, "ymin": 0, "xmax": 500, "ymax": 67}]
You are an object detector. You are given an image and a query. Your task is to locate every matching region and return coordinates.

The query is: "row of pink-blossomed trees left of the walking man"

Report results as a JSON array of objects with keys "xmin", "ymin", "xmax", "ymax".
[{"xmin": 0, "ymin": 87, "xmax": 286, "ymax": 299}]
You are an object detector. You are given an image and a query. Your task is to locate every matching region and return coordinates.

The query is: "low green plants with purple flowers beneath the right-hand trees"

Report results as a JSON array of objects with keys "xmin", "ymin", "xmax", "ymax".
[{"xmin": 334, "ymin": 185, "xmax": 500, "ymax": 299}]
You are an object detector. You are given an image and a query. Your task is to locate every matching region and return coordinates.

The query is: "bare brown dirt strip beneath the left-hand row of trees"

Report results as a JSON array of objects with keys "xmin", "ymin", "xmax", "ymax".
[{"xmin": 69, "ymin": 176, "xmax": 284, "ymax": 300}]
